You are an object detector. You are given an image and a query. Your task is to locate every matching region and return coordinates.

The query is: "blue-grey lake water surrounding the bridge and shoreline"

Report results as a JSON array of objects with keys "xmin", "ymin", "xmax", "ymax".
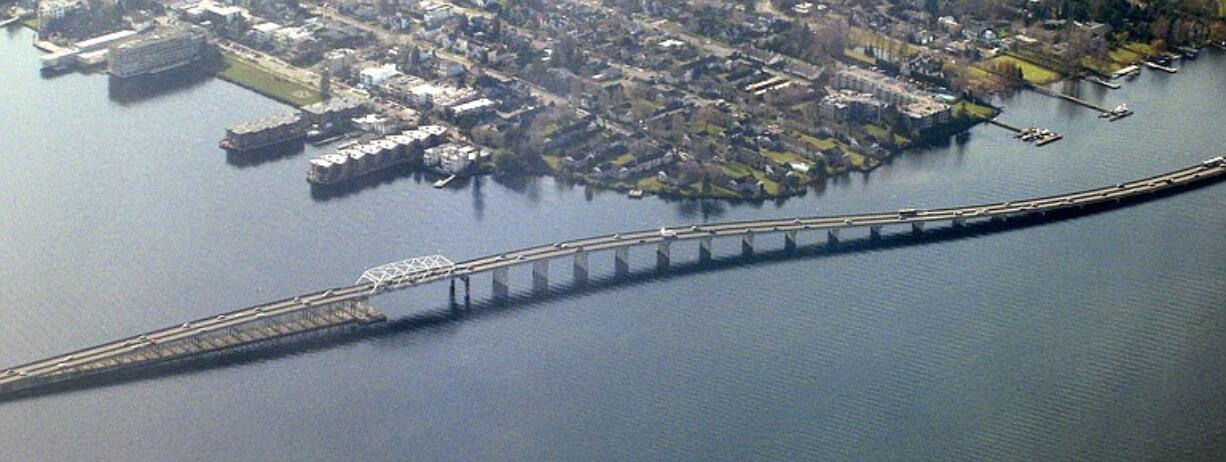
[{"xmin": 0, "ymin": 29, "xmax": 1226, "ymax": 461}]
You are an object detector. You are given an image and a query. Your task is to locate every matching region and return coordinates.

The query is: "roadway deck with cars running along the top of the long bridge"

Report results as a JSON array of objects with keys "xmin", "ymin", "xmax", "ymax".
[{"xmin": 0, "ymin": 157, "xmax": 1226, "ymax": 393}]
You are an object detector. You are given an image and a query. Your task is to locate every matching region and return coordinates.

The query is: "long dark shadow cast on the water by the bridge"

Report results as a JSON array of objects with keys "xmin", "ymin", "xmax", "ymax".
[{"xmin": 0, "ymin": 172, "xmax": 1224, "ymax": 403}]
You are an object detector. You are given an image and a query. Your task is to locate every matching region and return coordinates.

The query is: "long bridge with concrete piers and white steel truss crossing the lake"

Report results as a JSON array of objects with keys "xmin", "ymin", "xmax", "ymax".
[{"xmin": 0, "ymin": 157, "xmax": 1226, "ymax": 400}]
